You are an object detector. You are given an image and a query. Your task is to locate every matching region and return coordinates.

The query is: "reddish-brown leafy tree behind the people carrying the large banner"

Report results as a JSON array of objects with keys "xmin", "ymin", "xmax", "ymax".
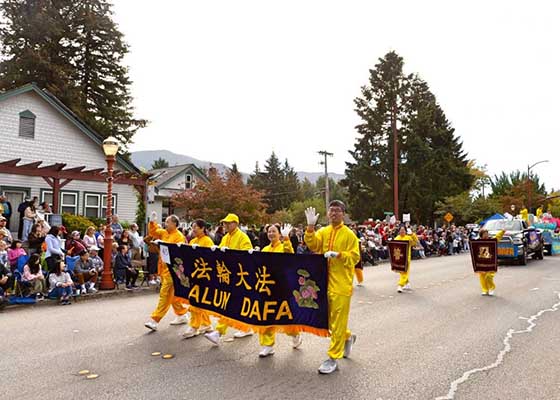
[{"xmin": 172, "ymin": 168, "xmax": 266, "ymax": 224}]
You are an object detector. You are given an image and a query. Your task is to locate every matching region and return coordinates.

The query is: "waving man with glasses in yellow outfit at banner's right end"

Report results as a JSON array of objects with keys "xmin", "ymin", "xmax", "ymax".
[{"xmin": 304, "ymin": 200, "xmax": 360, "ymax": 374}]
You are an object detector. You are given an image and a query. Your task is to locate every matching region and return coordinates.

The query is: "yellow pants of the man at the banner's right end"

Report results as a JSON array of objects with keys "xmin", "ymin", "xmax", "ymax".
[{"xmin": 327, "ymin": 292, "xmax": 351, "ymax": 360}]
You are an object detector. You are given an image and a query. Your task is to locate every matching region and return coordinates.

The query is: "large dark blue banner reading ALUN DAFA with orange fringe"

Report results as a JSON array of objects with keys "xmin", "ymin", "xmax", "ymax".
[{"xmin": 160, "ymin": 243, "xmax": 329, "ymax": 336}]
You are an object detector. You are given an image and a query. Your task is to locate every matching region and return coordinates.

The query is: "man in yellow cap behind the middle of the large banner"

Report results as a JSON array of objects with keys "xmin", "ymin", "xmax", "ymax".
[{"xmin": 204, "ymin": 214, "xmax": 253, "ymax": 345}]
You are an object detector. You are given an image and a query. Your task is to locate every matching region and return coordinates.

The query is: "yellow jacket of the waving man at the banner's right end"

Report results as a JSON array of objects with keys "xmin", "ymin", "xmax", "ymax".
[{"xmin": 304, "ymin": 223, "xmax": 360, "ymax": 296}]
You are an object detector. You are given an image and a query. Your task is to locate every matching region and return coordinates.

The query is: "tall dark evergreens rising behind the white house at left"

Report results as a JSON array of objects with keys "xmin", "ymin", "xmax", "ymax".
[{"xmin": 0, "ymin": 0, "xmax": 146, "ymax": 146}]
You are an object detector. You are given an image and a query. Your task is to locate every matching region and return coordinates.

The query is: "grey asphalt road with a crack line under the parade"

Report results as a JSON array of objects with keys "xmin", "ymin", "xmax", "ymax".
[{"xmin": 0, "ymin": 255, "xmax": 560, "ymax": 400}]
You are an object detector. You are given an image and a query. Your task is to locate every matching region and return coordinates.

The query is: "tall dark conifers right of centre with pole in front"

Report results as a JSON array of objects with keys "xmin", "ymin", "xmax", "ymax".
[{"xmin": 341, "ymin": 52, "xmax": 473, "ymax": 223}]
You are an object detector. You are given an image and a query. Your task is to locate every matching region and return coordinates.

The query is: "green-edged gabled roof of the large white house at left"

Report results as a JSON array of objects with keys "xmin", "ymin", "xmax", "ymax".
[{"xmin": 0, "ymin": 83, "xmax": 142, "ymax": 174}]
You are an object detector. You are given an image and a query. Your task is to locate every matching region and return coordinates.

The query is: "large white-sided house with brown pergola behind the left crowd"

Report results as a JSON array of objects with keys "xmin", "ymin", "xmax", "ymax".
[{"xmin": 0, "ymin": 84, "xmax": 146, "ymax": 231}]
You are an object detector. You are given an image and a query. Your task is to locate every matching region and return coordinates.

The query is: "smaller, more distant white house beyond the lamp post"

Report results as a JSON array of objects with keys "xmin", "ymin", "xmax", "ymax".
[{"xmin": 146, "ymin": 164, "xmax": 208, "ymax": 220}]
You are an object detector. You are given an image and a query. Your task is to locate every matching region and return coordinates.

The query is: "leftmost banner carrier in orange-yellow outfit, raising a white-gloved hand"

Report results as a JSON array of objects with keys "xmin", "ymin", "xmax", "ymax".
[{"xmin": 144, "ymin": 211, "xmax": 188, "ymax": 331}]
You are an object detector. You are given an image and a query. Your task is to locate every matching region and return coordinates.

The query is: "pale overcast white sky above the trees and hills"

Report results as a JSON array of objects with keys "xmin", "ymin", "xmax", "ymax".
[{"xmin": 114, "ymin": 0, "xmax": 560, "ymax": 190}]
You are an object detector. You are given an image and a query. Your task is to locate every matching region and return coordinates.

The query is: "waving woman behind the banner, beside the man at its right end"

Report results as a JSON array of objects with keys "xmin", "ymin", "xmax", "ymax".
[{"xmin": 259, "ymin": 224, "xmax": 302, "ymax": 357}]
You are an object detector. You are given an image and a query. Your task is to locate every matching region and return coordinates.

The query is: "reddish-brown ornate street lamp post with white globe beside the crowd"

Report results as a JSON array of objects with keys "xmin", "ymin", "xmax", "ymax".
[{"xmin": 99, "ymin": 136, "xmax": 119, "ymax": 290}]
